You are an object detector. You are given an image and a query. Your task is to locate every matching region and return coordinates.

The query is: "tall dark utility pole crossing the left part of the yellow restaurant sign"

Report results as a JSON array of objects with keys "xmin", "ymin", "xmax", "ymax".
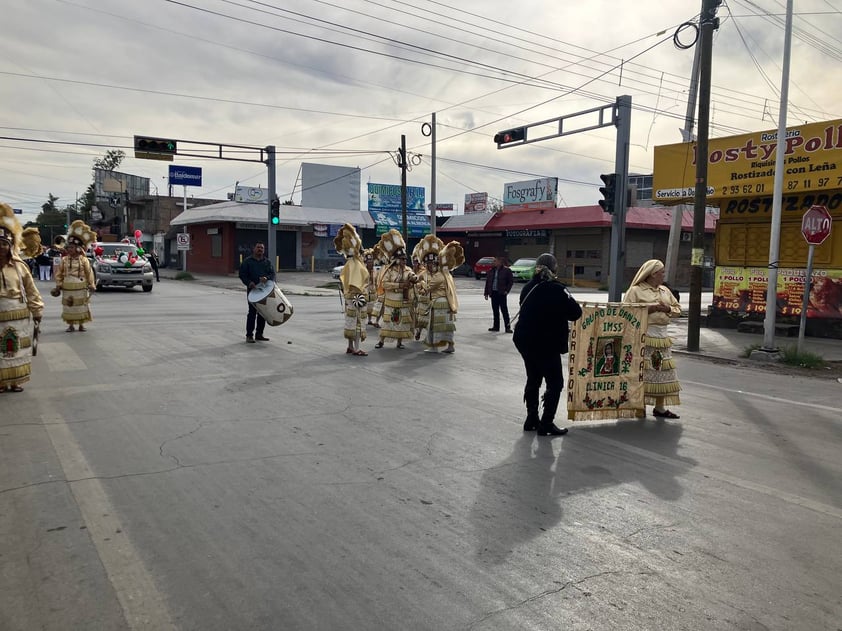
[{"xmin": 687, "ymin": 0, "xmax": 722, "ymax": 352}]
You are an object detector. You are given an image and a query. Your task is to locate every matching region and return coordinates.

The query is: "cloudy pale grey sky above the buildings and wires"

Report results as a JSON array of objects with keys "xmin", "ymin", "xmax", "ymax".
[{"xmin": 0, "ymin": 0, "xmax": 842, "ymax": 221}]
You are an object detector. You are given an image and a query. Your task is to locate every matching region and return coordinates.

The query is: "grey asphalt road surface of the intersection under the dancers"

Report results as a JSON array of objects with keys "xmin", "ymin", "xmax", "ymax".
[{"xmin": 0, "ymin": 281, "xmax": 842, "ymax": 631}]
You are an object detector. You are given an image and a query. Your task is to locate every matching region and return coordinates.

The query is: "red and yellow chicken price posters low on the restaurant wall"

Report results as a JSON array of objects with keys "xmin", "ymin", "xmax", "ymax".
[{"xmin": 713, "ymin": 266, "xmax": 842, "ymax": 318}]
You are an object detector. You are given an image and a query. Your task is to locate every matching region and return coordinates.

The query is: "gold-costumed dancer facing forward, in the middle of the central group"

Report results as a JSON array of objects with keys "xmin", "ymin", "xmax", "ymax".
[{"xmin": 374, "ymin": 228, "xmax": 418, "ymax": 348}]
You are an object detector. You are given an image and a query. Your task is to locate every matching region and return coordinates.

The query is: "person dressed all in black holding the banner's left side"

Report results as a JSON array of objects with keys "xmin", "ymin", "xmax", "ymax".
[{"xmin": 513, "ymin": 254, "xmax": 582, "ymax": 436}]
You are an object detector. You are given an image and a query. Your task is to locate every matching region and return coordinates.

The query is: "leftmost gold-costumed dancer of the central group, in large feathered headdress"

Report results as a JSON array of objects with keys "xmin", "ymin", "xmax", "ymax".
[{"xmin": 333, "ymin": 223, "xmax": 369, "ymax": 357}]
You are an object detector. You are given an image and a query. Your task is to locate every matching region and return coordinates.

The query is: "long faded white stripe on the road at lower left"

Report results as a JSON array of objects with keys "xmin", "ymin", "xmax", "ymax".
[{"xmin": 44, "ymin": 409, "xmax": 176, "ymax": 631}]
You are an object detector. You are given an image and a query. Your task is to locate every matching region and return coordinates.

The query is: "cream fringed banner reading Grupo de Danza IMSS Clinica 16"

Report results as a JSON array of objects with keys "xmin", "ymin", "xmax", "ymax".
[{"xmin": 567, "ymin": 303, "xmax": 648, "ymax": 421}]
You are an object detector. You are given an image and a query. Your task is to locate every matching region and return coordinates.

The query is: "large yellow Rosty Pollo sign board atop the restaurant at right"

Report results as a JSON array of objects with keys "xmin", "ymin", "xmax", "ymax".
[{"xmin": 652, "ymin": 119, "xmax": 842, "ymax": 204}]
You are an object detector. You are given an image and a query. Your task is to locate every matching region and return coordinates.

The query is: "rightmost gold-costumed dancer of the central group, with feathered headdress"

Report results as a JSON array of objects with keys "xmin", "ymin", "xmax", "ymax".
[{"xmin": 421, "ymin": 235, "xmax": 465, "ymax": 353}]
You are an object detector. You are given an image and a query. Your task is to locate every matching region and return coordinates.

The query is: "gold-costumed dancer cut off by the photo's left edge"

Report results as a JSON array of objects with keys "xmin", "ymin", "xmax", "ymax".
[{"xmin": 0, "ymin": 202, "xmax": 44, "ymax": 392}]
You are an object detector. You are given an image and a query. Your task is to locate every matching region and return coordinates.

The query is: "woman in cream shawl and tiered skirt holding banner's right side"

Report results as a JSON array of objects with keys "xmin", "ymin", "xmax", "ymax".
[{"xmin": 623, "ymin": 259, "xmax": 681, "ymax": 419}]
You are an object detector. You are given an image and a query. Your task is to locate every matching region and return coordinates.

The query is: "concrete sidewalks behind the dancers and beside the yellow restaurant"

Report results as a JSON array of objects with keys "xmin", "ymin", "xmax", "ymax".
[{"xmin": 160, "ymin": 268, "xmax": 842, "ymax": 364}]
